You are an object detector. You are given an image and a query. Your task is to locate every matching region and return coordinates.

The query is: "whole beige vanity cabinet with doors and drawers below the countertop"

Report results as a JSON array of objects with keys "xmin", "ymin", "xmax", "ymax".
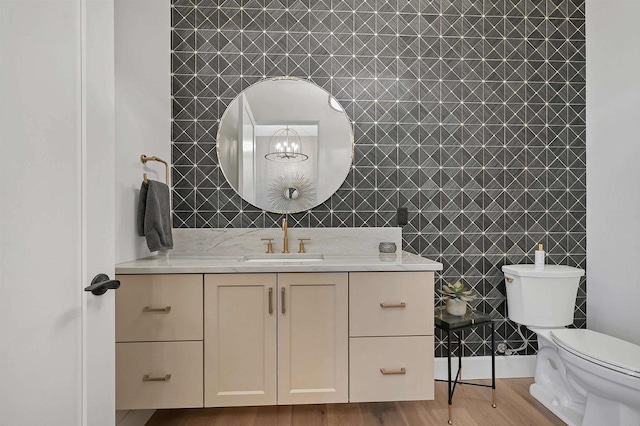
[{"xmin": 116, "ymin": 271, "xmax": 434, "ymax": 410}]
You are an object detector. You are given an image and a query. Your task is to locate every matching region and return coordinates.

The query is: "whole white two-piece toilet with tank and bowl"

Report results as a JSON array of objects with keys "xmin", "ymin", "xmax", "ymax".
[{"xmin": 502, "ymin": 265, "xmax": 640, "ymax": 426}]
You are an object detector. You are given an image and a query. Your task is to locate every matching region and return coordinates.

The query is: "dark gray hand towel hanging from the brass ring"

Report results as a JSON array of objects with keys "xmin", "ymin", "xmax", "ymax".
[{"xmin": 137, "ymin": 180, "xmax": 173, "ymax": 251}]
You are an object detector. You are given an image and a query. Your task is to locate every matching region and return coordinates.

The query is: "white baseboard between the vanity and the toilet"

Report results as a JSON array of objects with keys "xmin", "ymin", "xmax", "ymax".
[{"xmin": 435, "ymin": 355, "xmax": 536, "ymax": 380}]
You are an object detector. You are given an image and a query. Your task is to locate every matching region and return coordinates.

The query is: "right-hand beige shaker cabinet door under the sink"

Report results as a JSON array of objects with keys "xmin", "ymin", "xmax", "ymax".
[{"xmin": 278, "ymin": 273, "xmax": 349, "ymax": 404}]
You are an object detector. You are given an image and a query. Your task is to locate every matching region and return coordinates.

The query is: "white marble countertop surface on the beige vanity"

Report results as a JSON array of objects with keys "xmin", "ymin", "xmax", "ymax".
[{"xmin": 116, "ymin": 251, "xmax": 442, "ymax": 274}]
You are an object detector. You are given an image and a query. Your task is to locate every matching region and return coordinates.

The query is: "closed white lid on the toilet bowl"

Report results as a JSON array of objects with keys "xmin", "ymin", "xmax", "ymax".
[{"xmin": 551, "ymin": 328, "xmax": 640, "ymax": 376}]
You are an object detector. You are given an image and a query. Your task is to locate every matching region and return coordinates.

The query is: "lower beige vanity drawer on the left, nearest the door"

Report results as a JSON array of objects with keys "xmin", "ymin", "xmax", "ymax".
[{"xmin": 116, "ymin": 342, "xmax": 203, "ymax": 410}]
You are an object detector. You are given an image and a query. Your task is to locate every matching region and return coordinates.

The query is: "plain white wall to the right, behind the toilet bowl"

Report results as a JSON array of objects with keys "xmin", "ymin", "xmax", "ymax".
[{"xmin": 586, "ymin": 0, "xmax": 640, "ymax": 344}]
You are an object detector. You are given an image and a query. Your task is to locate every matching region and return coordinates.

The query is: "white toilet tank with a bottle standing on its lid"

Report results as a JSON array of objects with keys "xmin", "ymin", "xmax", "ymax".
[{"xmin": 502, "ymin": 265, "xmax": 584, "ymax": 327}]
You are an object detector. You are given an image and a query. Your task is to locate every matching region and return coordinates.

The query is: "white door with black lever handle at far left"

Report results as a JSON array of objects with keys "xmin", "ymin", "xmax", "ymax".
[{"xmin": 0, "ymin": 0, "xmax": 115, "ymax": 426}]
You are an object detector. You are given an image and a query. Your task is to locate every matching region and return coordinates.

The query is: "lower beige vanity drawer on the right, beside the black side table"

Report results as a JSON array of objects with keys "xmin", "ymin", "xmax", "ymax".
[{"xmin": 349, "ymin": 336, "xmax": 434, "ymax": 402}]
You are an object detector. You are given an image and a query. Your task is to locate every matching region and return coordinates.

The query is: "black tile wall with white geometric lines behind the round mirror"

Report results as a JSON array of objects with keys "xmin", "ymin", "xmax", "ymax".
[{"xmin": 171, "ymin": 0, "xmax": 586, "ymax": 355}]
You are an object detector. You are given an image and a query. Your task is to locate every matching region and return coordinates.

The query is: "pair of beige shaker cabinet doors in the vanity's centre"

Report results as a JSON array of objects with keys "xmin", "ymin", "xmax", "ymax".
[{"xmin": 204, "ymin": 273, "xmax": 349, "ymax": 407}]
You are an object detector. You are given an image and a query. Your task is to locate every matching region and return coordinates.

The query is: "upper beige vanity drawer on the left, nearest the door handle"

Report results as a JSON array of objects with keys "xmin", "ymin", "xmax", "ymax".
[{"xmin": 116, "ymin": 274, "xmax": 203, "ymax": 342}]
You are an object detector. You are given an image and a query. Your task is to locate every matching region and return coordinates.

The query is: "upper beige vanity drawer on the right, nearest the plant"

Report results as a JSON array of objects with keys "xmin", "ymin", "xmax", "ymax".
[{"xmin": 349, "ymin": 272, "xmax": 434, "ymax": 337}]
